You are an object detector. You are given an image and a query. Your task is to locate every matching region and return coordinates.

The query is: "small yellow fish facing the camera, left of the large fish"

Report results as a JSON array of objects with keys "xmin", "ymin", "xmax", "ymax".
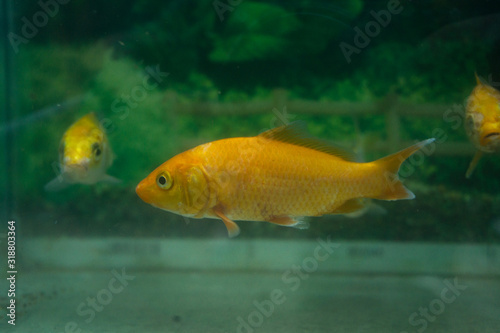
[{"xmin": 45, "ymin": 112, "xmax": 120, "ymax": 191}]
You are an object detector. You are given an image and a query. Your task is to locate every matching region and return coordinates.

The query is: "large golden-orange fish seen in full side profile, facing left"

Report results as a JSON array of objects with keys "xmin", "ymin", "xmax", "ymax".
[{"xmin": 136, "ymin": 123, "xmax": 434, "ymax": 237}]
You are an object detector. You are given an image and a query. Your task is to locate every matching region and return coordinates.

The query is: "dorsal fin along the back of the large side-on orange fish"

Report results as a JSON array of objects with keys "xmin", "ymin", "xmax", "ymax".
[{"xmin": 259, "ymin": 121, "xmax": 356, "ymax": 161}]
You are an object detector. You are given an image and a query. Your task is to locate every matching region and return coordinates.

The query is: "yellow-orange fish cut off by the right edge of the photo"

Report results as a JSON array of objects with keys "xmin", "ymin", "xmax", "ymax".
[{"xmin": 464, "ymin": 74, "xmax": 500, "ymax": 178}]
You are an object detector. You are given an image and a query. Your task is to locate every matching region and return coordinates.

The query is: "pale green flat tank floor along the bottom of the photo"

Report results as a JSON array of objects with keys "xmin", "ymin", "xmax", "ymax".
[{"xmin": 4, "ymin": 269, "xmax": 500, "ymax": 333}]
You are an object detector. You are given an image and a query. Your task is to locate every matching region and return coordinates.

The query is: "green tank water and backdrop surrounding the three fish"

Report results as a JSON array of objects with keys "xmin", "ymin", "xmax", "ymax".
[{"xmin": 0, "ymin": 0, "xmax": 500, "ymax": 333}]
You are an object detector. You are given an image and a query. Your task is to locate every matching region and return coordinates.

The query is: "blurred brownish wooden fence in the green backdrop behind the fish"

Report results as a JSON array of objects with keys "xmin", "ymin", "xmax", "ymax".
[{"xmin": 164, "ymin": 89, "xmax": 475, "ymax": 156}]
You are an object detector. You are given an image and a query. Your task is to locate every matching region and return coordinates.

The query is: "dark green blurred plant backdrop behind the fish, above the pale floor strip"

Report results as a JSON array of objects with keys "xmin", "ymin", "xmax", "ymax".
[{"xmin": 1, "ymin": 0, "xmax": 500, "ymax": 242}]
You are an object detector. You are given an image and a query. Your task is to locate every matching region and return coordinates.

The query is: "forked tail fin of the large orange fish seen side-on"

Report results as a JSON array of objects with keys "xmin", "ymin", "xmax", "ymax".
[{"xmin": 373, "ymin": 139, "xmax": 435, "ymax": 200}]
